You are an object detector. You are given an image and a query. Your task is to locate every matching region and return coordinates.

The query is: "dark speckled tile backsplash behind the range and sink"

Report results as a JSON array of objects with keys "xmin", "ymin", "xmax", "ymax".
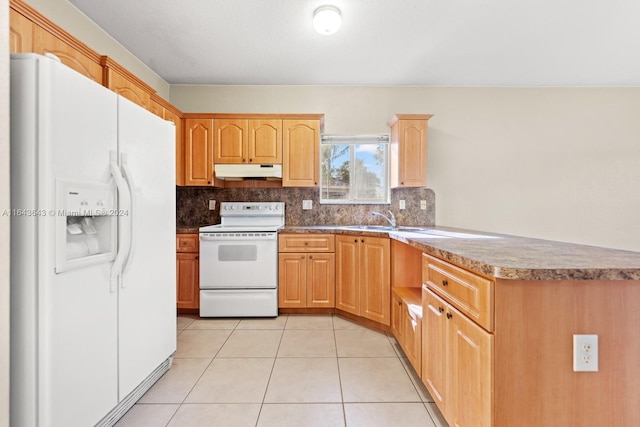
[{"xmin": 176, "ymin": 187, "xmax": 435, "ymax": 227}]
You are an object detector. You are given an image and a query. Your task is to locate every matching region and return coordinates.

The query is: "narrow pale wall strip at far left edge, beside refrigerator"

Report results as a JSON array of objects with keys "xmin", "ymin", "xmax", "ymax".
[{"xmin": 0, "ymin": 0, "xmax": 10, "ymax": 427}]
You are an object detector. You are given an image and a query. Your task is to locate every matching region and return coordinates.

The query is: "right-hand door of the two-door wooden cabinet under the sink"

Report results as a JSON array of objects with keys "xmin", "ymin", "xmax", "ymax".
[{"xmin": 360, "ymin": 237, "xmax": 391, "ymax": 326}]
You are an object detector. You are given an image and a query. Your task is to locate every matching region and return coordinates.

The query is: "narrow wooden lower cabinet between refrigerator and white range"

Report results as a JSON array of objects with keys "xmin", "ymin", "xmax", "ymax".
[{"xmin": 176, "ymin": 233, "xmax": 200, "ymax": 311}]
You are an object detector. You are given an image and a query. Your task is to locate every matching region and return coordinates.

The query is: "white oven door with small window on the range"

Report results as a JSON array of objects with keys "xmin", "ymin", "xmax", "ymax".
[{"xmin": 200, "ymin": 231, "xmax": 278, "ymax": 289}]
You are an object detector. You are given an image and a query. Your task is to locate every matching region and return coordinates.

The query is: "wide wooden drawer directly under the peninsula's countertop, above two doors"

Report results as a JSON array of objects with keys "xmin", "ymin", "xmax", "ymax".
[{"xmin": 422, "ymin": 254, "xmax": 494, "ymax": 332}]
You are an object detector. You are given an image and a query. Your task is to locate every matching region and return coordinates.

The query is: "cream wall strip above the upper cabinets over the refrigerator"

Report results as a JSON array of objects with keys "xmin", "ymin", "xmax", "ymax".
[{"xmin": 24, "ymin": 0, "xmax": 169, "ymax": 99}]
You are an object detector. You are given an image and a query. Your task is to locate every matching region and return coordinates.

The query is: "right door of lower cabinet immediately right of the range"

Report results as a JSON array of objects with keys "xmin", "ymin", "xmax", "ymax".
[{"xmin": 307, "ymin": 253, "xmax": 336, "ymax": 307}]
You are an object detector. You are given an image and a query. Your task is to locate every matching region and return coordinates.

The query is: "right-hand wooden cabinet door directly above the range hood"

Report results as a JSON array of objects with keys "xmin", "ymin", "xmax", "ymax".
[{"xmin": 247, "ymin": 119, "xmax": 282, "ymax": 164}]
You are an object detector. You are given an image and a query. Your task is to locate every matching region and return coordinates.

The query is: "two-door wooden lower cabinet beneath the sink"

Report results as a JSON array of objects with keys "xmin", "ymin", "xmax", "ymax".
[{"xmin": 336, "ymin": 235, "xmax": 391, "ymax": 326}]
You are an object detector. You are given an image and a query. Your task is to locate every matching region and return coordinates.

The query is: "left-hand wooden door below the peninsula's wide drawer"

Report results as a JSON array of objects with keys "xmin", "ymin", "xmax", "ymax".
[{"xmin": 421, "ymin": 286, "xmax": 449, "ymax": 419}]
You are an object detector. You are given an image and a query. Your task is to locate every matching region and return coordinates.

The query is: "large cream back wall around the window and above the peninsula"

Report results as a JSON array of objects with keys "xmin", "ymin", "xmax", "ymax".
[{"xmin": 170, "ymin": 85, "xmax": 640, "ymax": 251}]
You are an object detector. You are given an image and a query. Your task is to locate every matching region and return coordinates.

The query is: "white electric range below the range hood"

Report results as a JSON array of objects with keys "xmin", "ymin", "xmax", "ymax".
[{"xmin": 200, "ymin": 202, "xmax": 284, "ymax": 317}]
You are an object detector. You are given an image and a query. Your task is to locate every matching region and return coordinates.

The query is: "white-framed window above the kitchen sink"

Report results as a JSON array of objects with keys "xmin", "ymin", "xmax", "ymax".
[{"xmin": 320, "ymin": 135, "xmax": 389, "ymax": 204}]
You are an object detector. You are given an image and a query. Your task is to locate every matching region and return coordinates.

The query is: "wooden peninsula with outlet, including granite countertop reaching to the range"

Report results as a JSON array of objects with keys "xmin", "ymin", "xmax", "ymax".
[{"xmin": 280, "ymin": 226, "xmax": 640, "ymax": 426}]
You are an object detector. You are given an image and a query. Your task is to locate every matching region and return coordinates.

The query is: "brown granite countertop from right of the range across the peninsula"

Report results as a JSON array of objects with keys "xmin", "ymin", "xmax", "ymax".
[{"xmin": 280, "ymin": 226, "xmax": 640, "ymax": 280}]
